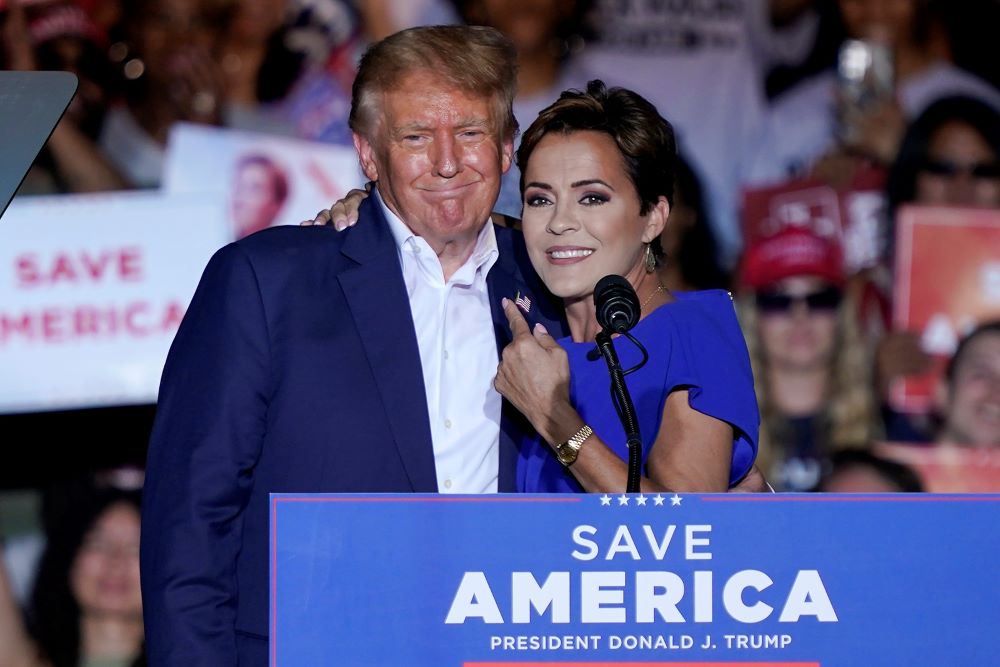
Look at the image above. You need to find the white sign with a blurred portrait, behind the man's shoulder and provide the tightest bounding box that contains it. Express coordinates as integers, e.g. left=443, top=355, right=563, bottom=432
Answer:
left=163, top=123, right=366, bottom=239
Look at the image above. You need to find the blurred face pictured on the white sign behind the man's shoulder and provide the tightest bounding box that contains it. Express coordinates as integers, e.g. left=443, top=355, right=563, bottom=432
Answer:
left=229, top=153, right=289, bottom=239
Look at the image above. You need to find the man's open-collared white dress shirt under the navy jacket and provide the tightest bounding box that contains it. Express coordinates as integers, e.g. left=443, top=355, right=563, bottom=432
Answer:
left=375, top=189, right=501, bottom=493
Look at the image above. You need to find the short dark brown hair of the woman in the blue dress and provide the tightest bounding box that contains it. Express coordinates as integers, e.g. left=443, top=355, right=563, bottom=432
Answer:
left=517, top=79, right=677, bottom=215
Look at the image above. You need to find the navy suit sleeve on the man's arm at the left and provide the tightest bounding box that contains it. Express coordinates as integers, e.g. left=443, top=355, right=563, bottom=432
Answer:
left=141, top=244, right=269, bottom=667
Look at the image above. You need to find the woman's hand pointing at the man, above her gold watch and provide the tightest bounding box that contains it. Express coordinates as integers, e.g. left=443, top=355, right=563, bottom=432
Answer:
left=493, top=299, right=583, bottom=443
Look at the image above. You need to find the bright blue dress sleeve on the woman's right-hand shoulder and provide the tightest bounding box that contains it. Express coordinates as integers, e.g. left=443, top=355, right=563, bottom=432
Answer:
left=667, top=291, right=760, bottom=486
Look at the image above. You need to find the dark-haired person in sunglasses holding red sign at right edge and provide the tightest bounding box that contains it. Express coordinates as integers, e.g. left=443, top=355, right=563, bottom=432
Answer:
left=876, top=96, right=1000, bottom=441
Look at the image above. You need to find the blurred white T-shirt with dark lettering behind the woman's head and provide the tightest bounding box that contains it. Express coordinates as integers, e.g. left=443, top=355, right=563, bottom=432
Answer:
left=578, top=0, right=817, bottom=271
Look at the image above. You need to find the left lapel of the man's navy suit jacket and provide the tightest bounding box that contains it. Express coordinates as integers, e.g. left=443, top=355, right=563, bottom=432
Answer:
left=339, top=199, right=438, bottom=492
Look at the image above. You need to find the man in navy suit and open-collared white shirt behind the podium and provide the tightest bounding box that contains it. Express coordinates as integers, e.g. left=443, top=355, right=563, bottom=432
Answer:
left=141, top=26, right=561, bottom=667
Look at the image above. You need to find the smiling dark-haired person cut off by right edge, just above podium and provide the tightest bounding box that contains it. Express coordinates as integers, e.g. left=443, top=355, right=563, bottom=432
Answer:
left=935, top=320, right=1000, bottom=447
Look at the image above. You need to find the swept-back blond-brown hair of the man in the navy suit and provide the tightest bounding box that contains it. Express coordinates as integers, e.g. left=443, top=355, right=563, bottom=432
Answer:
left=350, top=25, right=517, bottom=141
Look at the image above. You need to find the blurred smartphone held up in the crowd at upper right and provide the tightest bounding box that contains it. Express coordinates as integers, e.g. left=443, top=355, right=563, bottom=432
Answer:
left=837, top=39, right=895, bottom=144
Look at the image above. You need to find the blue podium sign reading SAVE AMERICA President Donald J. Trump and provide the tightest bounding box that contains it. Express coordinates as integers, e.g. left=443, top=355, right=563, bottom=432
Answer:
left=271, top=494, right=1000, bottom=667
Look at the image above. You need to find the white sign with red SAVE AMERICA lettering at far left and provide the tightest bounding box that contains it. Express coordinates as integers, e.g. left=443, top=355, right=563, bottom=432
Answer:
left=0, top=192, right=229, bottom=412
